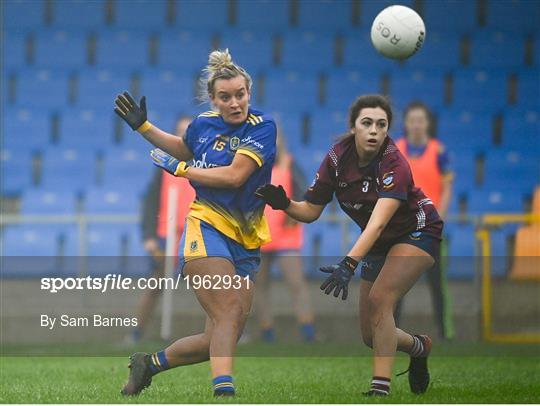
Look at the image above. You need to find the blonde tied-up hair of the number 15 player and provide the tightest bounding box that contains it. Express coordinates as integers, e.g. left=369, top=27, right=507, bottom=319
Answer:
left=200, top=49, right=252, bottom=101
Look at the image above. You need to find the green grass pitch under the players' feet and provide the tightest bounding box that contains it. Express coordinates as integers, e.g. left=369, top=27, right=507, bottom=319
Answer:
left=0, top=344, right=540, bottom=403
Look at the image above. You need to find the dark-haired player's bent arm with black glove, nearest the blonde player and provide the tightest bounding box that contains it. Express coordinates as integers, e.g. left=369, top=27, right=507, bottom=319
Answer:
left=255, top=184, right=324, bottom=223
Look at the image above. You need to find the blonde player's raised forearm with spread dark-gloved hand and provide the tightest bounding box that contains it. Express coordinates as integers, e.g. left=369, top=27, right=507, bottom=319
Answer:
left=114, top=92, right=192, bottom=161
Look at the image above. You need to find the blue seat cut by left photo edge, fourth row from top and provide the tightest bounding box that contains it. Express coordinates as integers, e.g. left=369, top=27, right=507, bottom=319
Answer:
left=3, top=108, right=51, bottom=151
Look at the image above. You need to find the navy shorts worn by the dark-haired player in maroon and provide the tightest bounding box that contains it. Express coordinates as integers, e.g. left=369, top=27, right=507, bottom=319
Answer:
left=359, top=231, right=441, bottom=282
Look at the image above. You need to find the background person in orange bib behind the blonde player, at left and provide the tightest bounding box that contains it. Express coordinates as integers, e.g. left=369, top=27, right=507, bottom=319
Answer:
left=126, top=116, right=195, bottom=344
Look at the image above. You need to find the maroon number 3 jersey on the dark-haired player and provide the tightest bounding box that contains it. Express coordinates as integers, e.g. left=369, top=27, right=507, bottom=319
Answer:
left=305, top=136, right=443, bottom=245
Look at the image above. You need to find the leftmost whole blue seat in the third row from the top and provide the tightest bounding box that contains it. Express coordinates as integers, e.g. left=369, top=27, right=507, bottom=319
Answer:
left=16, top=69, right=68, bottom=110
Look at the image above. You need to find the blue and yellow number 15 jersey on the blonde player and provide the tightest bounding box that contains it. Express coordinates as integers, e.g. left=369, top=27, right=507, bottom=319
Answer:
left=184, top=109, right=276, bottom=249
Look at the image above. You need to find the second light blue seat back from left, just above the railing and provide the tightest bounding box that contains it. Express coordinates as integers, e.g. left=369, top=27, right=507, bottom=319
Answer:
left=84, top=189, right=140, bottom=214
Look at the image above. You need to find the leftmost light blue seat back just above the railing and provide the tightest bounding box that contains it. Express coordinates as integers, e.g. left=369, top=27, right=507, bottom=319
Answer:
left=20, top=189, right=77, bottom=215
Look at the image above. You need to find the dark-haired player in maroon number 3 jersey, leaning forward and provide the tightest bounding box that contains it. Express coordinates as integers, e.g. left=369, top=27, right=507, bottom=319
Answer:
left=256, top=95, right=443, bottom=396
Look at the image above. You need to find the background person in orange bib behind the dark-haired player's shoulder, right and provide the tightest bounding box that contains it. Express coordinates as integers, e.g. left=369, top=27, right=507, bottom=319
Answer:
left=396, top=102, right=454, bottom=339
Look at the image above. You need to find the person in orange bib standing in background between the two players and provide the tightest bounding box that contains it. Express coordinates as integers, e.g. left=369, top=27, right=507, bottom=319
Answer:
left=254, top=132, right=315, bottom=342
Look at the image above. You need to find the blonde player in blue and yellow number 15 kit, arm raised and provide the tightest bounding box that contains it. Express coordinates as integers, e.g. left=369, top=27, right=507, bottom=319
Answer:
left=115, top=50, right=276, bottom=396
